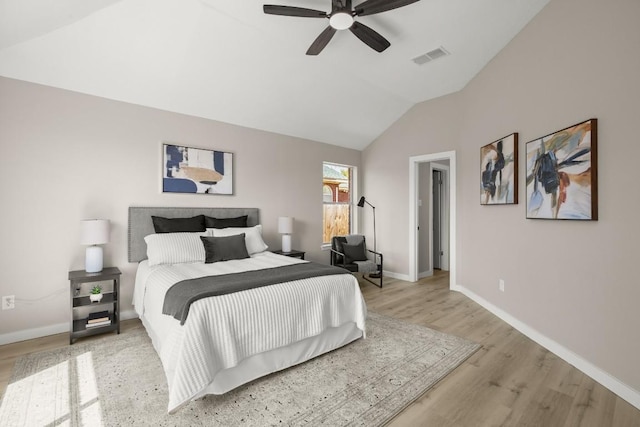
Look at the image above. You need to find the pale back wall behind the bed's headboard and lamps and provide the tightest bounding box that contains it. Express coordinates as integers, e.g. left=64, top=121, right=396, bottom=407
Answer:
left=0, top=78, right=360, bottom=343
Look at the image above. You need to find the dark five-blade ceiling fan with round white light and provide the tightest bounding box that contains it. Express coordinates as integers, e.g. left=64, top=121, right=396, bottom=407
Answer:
left=263, top=0, right=419, bottom=55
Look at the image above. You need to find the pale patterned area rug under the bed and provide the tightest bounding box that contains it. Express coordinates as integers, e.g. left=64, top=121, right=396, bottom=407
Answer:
left=0, top=313, right=479, bottom=427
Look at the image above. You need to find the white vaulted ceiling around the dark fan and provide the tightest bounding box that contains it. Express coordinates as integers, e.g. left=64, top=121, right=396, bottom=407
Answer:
left=0, top=0, right=549, bottom=149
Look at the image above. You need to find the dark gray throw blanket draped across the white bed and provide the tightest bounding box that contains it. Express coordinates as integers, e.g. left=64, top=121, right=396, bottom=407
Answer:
left=162, top=262, right=351, bottom=325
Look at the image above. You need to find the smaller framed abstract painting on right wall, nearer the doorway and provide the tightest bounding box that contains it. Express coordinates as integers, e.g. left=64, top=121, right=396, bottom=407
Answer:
left=480, top=133, right=518, bottom=205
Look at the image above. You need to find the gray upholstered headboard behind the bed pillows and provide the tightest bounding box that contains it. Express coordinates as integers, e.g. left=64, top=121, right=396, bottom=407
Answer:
left=128, top=206, right=260, bottom=262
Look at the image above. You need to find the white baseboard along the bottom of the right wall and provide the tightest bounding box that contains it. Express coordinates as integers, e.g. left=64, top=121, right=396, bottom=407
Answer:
left=451, top=285, right=640, bottom=409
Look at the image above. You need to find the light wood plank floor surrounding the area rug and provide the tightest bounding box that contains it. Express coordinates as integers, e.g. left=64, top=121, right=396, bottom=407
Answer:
left=0, top=272, right=640, bottom=427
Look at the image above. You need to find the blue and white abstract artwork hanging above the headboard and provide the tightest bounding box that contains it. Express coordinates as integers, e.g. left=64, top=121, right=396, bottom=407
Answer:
left=162, top=144, right=233, bottom=194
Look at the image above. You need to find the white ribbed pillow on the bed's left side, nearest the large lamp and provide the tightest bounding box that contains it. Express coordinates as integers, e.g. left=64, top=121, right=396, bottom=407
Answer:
left=144, top=233, right=205, bottom=265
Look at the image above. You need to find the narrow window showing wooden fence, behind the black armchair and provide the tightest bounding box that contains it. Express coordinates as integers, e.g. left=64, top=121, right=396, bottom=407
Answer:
left=322, top=162, right=354, bottom=244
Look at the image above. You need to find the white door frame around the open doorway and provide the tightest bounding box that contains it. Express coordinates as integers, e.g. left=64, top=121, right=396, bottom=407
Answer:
left=409, top=151, right=457, bottom=289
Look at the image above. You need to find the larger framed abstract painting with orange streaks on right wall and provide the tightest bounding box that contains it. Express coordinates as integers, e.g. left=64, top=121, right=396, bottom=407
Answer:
left=526, top=119, right=598, bottom=220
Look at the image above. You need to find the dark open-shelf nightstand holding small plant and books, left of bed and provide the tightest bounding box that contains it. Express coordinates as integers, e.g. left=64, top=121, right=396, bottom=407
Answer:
left=69, top=267, right=122, bottom=344
